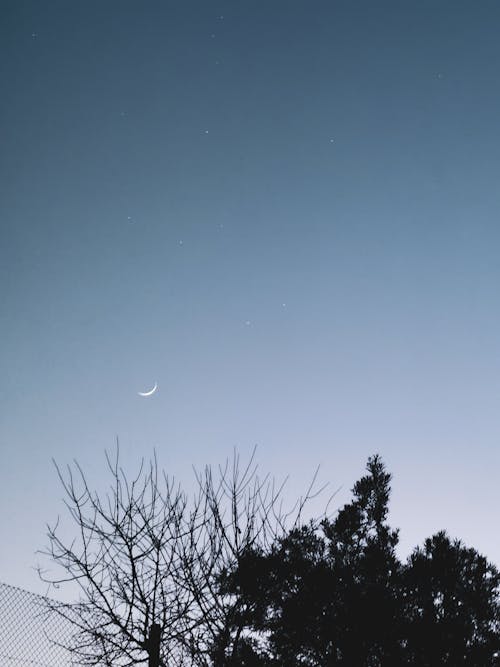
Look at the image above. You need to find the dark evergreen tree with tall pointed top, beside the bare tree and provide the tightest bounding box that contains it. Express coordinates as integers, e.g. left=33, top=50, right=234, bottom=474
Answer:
left=226, top=456, right=401, bottom=667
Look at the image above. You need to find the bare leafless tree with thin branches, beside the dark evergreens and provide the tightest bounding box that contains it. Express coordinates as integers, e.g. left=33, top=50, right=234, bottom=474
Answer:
left=39, top=445, right=328, bottom=667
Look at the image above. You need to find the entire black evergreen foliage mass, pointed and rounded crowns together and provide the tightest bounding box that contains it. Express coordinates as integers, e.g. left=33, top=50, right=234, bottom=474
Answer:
left=224, top=456, right=500, bottom=667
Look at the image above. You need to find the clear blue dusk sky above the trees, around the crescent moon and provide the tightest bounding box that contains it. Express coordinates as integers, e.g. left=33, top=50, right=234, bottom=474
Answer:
left=0, top=0, right=500, bottom=592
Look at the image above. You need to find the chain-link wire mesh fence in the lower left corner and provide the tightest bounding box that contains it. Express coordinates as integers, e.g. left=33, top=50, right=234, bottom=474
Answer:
left=0, top=583, right=76, bottom=667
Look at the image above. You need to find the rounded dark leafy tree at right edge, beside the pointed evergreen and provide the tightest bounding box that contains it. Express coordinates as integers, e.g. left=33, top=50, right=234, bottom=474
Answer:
left=404, top=531, right=500, bottom=667
